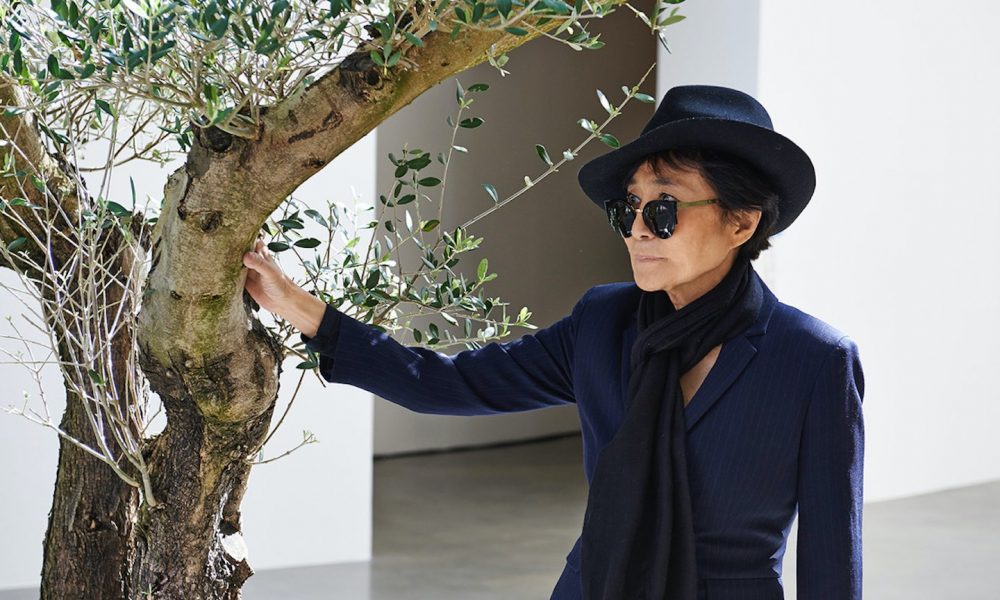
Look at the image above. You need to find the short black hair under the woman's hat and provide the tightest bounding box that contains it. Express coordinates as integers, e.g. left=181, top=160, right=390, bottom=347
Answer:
left=622, top=148, right=779, bottom=260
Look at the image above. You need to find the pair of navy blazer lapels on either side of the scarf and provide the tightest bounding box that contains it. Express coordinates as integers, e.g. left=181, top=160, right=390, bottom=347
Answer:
left=622, top=271, right=778, bottom=431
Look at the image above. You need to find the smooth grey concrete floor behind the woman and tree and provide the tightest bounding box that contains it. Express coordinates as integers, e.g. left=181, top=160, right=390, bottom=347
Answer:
left=0, top=436, right=1000, bottom=600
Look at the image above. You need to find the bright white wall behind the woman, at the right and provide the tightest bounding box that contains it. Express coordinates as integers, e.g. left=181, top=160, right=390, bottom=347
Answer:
left=758, top=0, right=1000, bottom=501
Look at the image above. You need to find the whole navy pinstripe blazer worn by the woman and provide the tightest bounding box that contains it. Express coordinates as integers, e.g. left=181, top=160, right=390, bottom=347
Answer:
left=301, top=272, right=864, bottom=600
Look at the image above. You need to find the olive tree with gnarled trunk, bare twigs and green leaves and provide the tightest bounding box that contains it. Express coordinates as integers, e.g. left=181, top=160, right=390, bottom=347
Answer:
left=0, top=0, right=683, bottom=599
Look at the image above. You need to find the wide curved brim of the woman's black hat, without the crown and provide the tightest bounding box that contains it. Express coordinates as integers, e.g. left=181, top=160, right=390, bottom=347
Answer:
left=577, top=117, right=816, bottom=235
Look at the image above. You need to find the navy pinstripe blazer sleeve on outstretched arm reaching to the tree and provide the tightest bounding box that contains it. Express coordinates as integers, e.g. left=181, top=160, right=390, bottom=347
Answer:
left=300, top=288, right=593, bottom=415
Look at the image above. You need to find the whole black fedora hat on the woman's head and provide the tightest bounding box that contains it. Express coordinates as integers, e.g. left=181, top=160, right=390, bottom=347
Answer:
left=577, top=85, right=816, bottom=235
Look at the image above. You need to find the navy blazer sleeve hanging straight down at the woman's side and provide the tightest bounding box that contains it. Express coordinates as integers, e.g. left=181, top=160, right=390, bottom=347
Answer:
left=796, top=336, right=865, bottom=600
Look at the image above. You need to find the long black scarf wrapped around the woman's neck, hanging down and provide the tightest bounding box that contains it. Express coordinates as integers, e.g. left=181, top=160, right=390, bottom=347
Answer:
left=580, top=258, right=763, bottom=600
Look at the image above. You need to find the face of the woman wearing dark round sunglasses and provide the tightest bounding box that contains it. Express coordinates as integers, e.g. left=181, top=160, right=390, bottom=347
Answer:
left=623, top=162, right=760, bottom=310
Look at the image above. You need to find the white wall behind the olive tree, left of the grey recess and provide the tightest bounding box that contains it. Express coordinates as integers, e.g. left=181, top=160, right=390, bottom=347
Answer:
left=0, top=133, right=375, bottom=589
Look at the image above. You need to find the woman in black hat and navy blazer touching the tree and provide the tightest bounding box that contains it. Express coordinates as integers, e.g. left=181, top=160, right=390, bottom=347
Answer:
left=244, top=85, right=864, bottom=600
